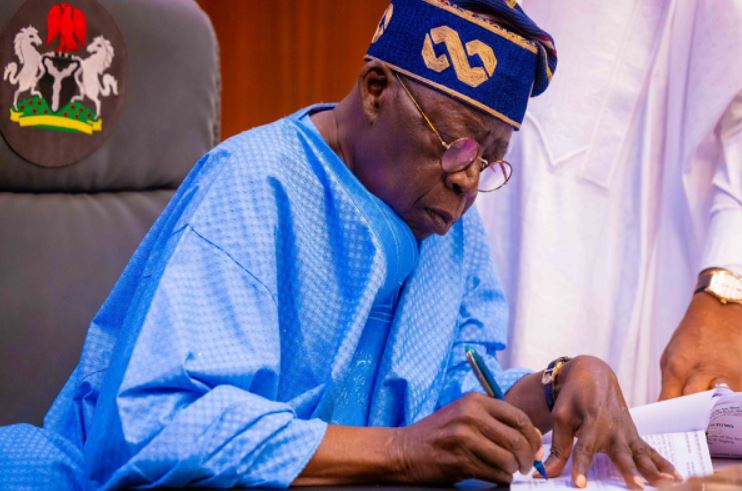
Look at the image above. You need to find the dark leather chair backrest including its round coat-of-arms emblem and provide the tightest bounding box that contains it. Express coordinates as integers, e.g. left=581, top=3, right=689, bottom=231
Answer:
left=0, top=0, right=220, bottom=425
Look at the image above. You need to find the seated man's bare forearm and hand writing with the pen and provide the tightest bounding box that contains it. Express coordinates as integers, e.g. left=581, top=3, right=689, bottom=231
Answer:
left=292, top=393, right=544, bottom=486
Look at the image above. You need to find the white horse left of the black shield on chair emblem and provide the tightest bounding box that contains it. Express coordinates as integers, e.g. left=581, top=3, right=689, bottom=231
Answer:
left=3, top=26, right=44, bottom=108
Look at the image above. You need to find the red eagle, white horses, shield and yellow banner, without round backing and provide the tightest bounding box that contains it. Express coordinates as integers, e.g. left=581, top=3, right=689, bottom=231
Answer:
left=3, top=2, right=118, bottom=135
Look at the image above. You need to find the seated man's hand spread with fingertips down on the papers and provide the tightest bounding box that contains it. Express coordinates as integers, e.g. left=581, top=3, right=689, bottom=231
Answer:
left=545, top=356, right=682, bottom=489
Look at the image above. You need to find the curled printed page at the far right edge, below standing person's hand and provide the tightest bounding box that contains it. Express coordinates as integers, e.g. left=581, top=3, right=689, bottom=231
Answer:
left=706, top=392, right=742, bottom=458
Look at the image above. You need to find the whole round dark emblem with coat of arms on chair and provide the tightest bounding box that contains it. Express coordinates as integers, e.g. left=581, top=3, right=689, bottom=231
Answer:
left=0, top=0, right=126, bottom=167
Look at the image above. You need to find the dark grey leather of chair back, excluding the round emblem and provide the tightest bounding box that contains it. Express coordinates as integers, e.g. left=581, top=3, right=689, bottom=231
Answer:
left=0, top=0, right=220, bottom=425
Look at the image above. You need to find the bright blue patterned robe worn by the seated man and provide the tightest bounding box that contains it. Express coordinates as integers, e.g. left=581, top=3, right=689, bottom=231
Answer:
left=0, top=106, right=526, bottom=488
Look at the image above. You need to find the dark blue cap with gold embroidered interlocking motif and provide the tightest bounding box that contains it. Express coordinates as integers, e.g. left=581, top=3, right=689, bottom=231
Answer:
left=366, top=0, right=557, bottom=129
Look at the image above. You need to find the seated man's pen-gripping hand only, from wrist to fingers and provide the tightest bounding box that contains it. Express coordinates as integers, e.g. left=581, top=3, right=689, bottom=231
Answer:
left=394, top=393, right=543, bottom=484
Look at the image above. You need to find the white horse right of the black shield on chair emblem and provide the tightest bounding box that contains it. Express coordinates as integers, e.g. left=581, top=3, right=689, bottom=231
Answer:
left=72, top=36, right=118, bottom=118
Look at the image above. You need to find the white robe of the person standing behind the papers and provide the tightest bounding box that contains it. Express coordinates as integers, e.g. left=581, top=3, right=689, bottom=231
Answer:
left=478, top=0, right=742, bottom=404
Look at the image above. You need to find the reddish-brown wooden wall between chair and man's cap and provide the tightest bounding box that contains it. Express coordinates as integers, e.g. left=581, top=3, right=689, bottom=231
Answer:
left=198, top=0, right=388, bottom=138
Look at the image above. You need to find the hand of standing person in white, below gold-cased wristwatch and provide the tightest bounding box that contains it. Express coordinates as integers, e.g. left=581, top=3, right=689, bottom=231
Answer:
left=660, top=292, right=742, bottom=400
